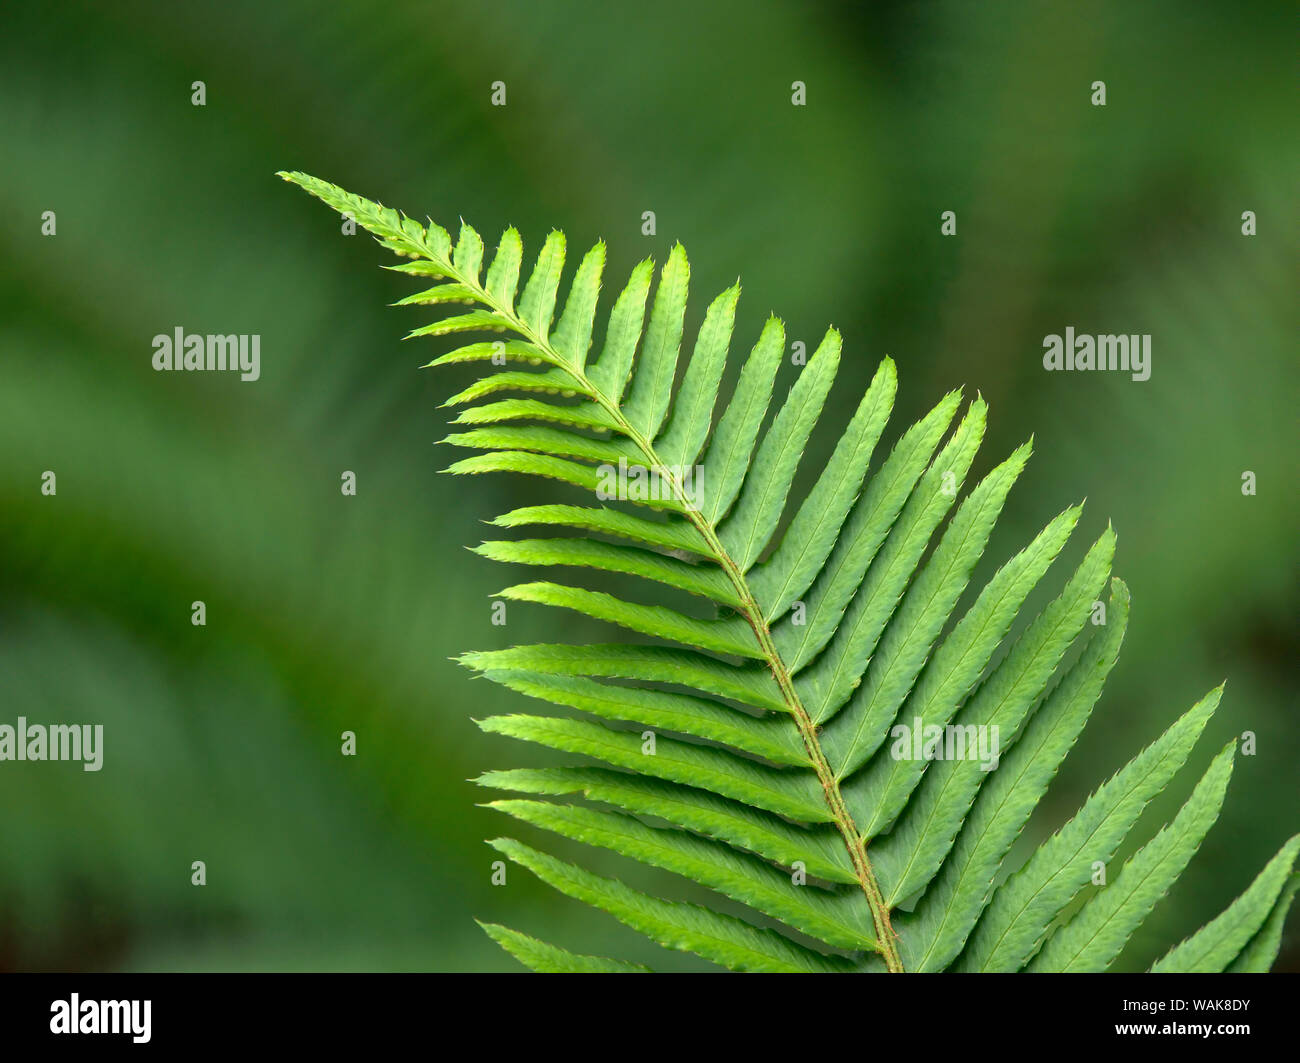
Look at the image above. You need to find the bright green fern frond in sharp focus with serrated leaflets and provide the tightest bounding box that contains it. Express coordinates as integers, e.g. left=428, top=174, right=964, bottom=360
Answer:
left=281, top=173, right=1300, bottom=971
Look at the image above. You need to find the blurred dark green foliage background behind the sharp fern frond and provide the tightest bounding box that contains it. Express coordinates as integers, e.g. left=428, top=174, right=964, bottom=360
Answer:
left=0, top=0, right=1300, bottom=969
